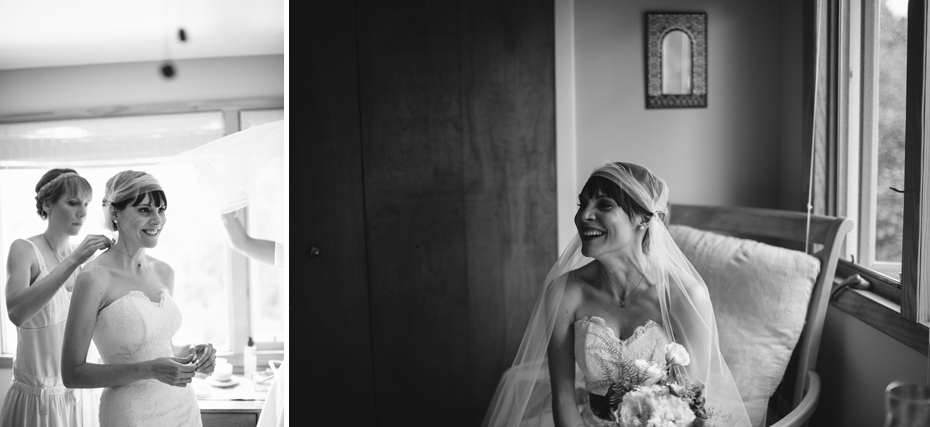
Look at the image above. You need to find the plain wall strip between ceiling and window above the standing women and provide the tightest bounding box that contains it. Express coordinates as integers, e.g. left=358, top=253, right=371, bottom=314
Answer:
left=0, top=55, right=284, bottom=399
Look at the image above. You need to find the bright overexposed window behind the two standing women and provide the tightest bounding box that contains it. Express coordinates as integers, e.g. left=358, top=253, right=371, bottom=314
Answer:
left=0, top=104, right=287, bottom=354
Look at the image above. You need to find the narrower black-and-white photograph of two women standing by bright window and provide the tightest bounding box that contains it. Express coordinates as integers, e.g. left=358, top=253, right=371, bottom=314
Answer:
left=0, top=0, right=286, bottom=427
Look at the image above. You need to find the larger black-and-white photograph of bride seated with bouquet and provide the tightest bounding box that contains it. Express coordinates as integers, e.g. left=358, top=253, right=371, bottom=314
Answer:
left=314, top=0, right=930, bottom=427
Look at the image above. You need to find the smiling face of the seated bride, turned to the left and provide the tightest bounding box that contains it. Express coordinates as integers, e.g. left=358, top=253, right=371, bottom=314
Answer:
left=575, top=192, right=638, bottom=258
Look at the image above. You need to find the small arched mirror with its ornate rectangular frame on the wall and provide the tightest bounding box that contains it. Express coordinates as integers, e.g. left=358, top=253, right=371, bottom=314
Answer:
left=646, top=12, right=707, bottom=108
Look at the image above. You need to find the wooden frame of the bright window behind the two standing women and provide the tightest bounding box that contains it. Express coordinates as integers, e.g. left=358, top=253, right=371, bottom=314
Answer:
left=0, top=97, right=284, bottom=374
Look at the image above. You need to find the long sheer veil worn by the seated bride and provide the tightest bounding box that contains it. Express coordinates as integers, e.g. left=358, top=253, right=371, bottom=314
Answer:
left=482, top=162, right=750, bottom=427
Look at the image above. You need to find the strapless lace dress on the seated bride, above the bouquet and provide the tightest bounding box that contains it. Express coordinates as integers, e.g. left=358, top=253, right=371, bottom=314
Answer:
left=575, top=316, right=669, bottom=427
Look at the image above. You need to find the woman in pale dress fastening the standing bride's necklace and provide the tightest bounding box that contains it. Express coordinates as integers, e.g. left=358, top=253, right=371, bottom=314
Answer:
left=0, top=169, right=113, bottom=427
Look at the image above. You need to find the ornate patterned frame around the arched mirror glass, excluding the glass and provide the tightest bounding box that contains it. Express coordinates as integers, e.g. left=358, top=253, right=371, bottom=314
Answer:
left=646, top=12, right=707, bottom=108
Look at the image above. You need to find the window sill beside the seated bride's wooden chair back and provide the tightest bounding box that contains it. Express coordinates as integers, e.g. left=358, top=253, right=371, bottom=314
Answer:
left=830, top=269, right=928, bottom=354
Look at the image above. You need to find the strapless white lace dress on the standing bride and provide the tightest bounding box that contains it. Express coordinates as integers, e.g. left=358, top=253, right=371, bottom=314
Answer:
left=94, top=291, right=202, bottom=427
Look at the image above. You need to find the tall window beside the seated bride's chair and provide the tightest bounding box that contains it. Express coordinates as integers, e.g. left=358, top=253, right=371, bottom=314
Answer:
left=839, top=0, right=930, bottom=320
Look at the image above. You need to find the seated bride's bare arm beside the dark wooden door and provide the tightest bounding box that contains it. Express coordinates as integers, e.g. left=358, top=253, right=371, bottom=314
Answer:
left=547, top=281, right=584, bottom=427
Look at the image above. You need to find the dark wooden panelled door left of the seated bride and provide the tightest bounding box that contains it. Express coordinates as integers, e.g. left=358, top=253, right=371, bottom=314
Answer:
left=308, top=0, right=557, bottom=426
